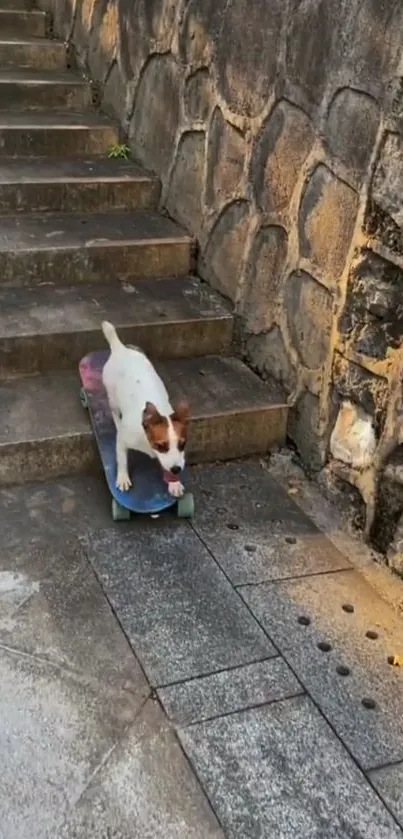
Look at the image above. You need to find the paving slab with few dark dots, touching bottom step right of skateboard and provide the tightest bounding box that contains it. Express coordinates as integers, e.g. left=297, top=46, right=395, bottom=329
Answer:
left=193, top=463, right=350, bottom=585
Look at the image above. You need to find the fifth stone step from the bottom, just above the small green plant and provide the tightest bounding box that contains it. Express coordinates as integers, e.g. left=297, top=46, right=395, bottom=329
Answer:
left=0, top=111, right=119, bottom=156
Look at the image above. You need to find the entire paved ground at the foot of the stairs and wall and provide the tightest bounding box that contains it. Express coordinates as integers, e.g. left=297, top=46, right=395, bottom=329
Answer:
left=0, top=460, right=403, bottom=839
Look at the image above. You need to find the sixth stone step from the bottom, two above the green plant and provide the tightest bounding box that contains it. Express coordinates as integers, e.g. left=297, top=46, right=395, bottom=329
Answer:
left=0, top=68, right=92, bottom=111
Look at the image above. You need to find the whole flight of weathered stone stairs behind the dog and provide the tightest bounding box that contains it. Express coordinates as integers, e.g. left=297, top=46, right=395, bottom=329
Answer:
left=0, top=0, right=287, bottom=485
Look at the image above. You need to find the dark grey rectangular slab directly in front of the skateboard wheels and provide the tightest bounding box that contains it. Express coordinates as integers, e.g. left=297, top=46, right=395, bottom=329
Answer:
left=84, top=519, right=275, bottom=686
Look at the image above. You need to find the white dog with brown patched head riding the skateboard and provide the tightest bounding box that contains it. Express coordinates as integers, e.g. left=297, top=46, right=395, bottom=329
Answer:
left=102, top=321, right=190, bottom=498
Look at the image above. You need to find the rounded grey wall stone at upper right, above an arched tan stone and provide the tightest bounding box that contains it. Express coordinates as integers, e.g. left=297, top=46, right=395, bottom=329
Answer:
left=326, top=88, right=380, bottom=186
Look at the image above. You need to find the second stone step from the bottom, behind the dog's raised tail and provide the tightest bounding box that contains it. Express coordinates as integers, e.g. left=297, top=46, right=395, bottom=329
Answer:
left=0, top=277, right=233, bottom=379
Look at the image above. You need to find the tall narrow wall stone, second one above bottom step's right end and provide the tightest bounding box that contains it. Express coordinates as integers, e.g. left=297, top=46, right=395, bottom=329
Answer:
left=239, top=226, right=288, bottom=334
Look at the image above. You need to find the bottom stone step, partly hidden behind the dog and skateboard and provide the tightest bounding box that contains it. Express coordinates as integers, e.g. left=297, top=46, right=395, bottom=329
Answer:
left=0, top=356, right=287, bottom=486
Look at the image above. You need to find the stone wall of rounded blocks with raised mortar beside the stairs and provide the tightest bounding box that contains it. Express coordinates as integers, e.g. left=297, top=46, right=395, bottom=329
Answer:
left=41, top=0, right=403, bottom=556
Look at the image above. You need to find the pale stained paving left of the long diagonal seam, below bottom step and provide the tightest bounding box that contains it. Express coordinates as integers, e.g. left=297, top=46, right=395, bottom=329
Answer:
left=0, top=477, right=224, bottom=839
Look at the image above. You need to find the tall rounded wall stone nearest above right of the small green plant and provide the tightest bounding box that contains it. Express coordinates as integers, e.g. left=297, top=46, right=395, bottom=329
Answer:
left=129, top=55, right=180, bottom=182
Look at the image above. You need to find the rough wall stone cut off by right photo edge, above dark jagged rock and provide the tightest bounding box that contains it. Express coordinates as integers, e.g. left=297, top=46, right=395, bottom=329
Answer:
left=372, top=134, right=403, bottom=227
